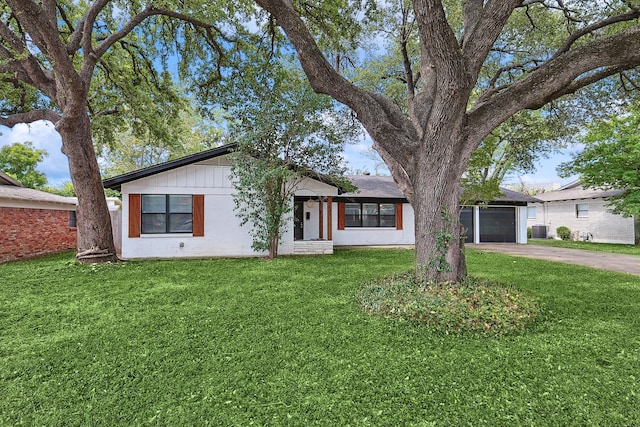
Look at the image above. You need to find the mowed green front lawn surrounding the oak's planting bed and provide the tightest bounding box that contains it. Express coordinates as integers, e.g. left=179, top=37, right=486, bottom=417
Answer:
left=0, top=249, right=640, bottom=426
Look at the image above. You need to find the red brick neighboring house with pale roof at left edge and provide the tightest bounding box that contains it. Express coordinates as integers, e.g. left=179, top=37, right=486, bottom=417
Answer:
left=0, top=172, right=77, bottom=263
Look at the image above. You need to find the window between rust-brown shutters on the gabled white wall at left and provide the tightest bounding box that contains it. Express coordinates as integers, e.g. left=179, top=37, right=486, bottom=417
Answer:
left=141, top=194, right=193, bottom=234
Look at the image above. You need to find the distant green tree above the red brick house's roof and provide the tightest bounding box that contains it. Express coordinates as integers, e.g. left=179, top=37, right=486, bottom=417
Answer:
left=0, top=142, right=48, bottom=189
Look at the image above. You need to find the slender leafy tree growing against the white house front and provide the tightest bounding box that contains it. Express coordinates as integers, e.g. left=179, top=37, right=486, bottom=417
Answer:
left=225, top=64, right=359, bottom=258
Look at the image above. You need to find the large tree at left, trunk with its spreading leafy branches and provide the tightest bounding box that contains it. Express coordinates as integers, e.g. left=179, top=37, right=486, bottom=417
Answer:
left=0, top=0, right=235, bottom=262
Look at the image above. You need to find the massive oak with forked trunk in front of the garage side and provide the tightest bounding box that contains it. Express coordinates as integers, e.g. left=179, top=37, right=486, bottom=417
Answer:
left=256, top=0, right=640, bottom=280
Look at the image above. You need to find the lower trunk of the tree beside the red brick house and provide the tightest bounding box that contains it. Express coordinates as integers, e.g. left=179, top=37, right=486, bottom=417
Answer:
left=56, top=112, right=118, bottom=263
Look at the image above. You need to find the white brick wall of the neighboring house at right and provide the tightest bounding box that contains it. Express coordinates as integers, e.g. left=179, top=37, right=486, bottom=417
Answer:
left=527, top=199, right=634, bottom=244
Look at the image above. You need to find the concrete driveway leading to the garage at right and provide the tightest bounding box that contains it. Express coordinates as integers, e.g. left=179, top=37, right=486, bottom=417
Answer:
left=466, top=243, right=640, bottom=275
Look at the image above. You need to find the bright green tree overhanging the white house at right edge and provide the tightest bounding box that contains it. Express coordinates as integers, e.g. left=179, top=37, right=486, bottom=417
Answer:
left=558, top=103, right=640, bottom=216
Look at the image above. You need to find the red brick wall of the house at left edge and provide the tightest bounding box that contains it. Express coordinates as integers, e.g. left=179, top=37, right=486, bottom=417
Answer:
left=0, top=207, right=76, bottom=263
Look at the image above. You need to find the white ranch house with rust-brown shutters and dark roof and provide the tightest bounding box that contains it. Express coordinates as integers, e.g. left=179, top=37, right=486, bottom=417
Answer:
left=104, top=145, right=535, bottom=259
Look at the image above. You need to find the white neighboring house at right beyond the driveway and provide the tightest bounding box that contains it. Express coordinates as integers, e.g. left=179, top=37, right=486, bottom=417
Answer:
left=527, top=181, right=640, bottom=245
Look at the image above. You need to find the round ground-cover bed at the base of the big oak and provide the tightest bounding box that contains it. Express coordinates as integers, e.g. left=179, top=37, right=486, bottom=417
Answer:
left=357, top=272, right=538, bottom=336
